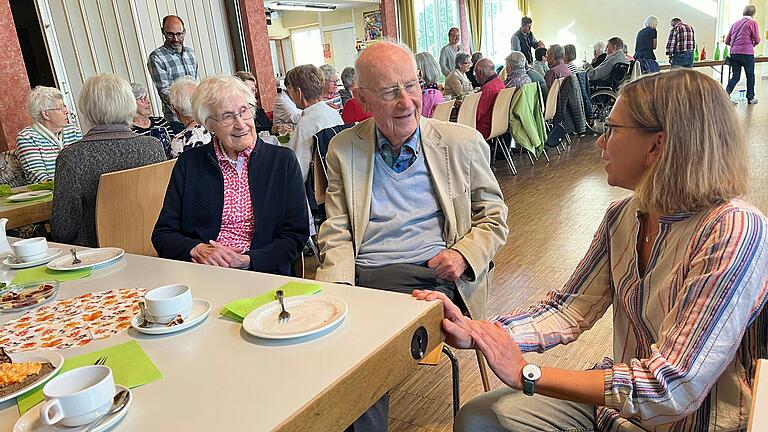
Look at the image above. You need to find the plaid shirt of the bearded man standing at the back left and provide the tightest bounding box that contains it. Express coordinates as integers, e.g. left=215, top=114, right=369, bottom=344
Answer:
left=147, top=45, right=200, bottom=121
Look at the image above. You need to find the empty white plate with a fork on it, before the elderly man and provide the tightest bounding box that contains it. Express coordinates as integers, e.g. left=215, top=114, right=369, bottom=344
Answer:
left=243, top=294, right=347, bottom=339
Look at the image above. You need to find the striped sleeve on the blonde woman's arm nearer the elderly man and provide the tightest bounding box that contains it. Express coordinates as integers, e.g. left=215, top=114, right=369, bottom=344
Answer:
left=491, top=198, right=629, bottom=352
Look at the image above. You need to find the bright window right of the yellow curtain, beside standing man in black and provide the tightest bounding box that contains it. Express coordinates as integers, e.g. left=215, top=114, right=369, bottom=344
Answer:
left=480, top=0, right=520, bottom=65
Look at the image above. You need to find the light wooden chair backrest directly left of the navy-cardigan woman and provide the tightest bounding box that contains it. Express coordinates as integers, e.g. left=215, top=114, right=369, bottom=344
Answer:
left=96, top=159, right=176, bottom=256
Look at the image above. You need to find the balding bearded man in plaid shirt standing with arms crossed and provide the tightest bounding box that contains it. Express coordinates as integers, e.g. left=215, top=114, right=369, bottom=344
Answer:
left=147, top=15, right=200, bottom=134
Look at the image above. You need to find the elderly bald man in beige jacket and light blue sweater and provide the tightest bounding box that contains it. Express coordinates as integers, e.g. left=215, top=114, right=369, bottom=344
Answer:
left=317, top=38, right=508, bottom=431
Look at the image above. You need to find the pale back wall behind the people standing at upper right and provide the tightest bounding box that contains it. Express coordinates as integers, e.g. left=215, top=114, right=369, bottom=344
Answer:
left=528, top=0, right=719, bottom=60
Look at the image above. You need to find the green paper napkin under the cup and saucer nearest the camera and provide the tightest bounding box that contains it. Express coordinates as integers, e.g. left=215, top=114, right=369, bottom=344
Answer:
left=16, top=340, right=163, bottom=415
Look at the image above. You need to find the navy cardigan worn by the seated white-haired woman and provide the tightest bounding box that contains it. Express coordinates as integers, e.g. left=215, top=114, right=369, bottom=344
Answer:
left=152, top=139, right=309, bottom=275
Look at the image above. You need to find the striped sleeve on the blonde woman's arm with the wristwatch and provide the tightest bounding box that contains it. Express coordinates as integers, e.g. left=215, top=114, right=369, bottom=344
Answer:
left=605, top=207, right=768, bottom=425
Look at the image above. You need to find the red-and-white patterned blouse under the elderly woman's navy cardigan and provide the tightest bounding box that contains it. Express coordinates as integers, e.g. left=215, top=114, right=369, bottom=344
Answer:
left=213, top=138, right=256, bottom=252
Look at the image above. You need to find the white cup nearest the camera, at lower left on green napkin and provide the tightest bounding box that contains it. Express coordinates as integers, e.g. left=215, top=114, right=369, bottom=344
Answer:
left=40, top=366, right=115, bottom=427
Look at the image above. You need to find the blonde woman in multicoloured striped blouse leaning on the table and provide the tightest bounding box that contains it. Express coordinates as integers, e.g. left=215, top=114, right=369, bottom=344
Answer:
left=414, top=69, right=768, bottom=431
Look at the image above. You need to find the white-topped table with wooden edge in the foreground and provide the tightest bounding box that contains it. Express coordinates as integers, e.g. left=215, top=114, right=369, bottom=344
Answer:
left=0, top=248, right=442, bottom=431
